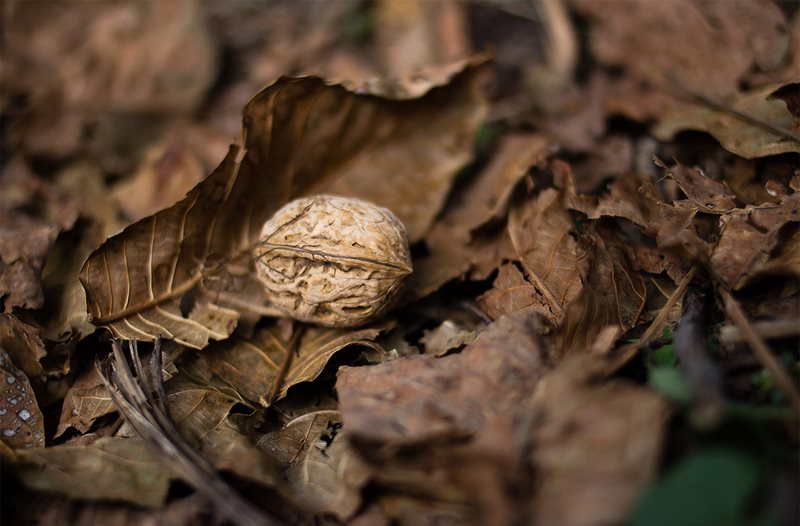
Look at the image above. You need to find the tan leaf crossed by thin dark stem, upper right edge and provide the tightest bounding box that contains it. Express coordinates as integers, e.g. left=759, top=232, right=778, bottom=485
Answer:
left=653, top=84, right=800, bottom=159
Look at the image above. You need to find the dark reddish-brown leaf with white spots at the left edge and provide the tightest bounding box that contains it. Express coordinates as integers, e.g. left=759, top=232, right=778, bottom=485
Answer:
left=0, top=349, right=44, bottom=449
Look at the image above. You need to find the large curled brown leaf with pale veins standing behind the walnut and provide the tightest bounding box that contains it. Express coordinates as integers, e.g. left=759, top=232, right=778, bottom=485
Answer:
left=81, top=59, right=484, bottom=348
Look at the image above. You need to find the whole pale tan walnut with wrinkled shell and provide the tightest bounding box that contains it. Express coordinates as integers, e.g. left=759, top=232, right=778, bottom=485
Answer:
left=255, top=195, right=411, bottom=327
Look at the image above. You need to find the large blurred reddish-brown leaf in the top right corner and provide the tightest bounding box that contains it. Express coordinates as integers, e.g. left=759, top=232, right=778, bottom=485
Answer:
left=571, top=0, right=791, bottom=96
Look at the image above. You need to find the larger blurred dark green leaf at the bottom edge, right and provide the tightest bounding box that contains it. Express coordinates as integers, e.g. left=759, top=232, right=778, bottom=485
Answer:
left=630, top=448, right=760, bottom=526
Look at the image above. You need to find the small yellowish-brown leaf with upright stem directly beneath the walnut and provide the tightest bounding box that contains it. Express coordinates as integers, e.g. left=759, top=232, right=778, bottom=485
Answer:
left=176, top=324, right=386, bottom=407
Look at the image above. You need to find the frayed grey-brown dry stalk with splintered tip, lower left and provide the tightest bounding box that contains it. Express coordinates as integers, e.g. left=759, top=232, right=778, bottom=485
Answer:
left=95, top=341, right=281, bottom=526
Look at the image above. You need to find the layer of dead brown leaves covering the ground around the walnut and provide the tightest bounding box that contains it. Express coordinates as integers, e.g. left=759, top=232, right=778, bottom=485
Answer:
left=0, top=0, right=800, bottom=526
